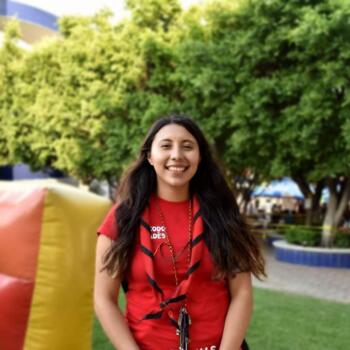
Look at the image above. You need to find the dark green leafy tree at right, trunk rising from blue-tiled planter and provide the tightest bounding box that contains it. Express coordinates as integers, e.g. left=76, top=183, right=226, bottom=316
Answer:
left=208, top=0, right=350, bottom=245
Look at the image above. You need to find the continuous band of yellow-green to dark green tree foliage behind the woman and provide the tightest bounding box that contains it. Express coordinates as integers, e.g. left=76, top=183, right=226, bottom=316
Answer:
left=0, top=0, right=350, bottom=202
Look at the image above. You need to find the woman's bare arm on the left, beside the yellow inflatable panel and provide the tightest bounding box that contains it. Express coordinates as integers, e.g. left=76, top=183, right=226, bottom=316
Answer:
left=94, top=235, right=139, bottom=350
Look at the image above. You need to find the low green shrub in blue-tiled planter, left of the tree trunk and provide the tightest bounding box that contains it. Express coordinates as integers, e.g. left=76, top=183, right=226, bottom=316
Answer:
left=284, top=226, right=321, bottom=247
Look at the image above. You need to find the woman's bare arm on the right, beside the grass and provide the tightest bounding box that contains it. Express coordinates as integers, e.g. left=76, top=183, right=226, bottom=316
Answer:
left=220, top=272, right=253, bottom=350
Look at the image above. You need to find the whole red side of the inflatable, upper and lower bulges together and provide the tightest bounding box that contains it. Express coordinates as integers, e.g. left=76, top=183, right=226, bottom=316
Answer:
left=0, top=188, right=46, bottom=350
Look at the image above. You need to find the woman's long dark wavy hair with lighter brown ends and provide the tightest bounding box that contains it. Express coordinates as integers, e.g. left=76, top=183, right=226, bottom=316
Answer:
left=103, top=115, right=266, bottom=279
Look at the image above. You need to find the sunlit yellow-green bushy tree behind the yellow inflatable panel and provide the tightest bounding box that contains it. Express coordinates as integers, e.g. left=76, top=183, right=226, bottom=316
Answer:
left=16, top=13, right=143, bottom=183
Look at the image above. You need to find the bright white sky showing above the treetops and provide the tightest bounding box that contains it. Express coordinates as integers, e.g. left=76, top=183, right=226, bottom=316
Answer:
left=16, top=0, right=203, bottom=19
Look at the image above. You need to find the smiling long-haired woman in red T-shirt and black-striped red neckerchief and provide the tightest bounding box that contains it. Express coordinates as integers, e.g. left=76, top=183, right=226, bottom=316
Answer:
left=94, top=116, right=265, bottom=350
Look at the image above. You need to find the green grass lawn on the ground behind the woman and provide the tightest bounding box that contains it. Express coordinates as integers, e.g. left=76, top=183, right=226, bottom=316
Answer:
left=93, top=288, right=350, bottom=350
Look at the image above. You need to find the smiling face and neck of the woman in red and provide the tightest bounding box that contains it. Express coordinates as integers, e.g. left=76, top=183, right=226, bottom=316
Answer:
left=148, top=124, right=200, bottom=195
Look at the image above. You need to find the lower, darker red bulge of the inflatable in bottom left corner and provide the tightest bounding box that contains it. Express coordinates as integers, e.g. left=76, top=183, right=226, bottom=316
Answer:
left=0, top=273, right=34, bottom=350
